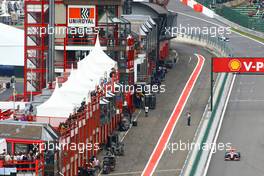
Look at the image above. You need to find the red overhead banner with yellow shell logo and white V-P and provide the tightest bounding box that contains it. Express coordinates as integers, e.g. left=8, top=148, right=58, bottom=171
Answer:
left=212, top=58, right=264, bottom=73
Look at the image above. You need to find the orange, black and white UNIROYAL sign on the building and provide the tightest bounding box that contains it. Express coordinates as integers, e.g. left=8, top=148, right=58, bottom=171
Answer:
left=68, top=5, right=96, bottom=27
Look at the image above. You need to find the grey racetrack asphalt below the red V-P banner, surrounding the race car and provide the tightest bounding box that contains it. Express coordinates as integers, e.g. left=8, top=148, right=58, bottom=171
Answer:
left=207, top=75, right=264, bottom=176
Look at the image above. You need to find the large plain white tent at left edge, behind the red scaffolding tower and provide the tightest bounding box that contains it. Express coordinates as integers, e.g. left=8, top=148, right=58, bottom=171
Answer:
left=0, top=23, right=24, bottom=66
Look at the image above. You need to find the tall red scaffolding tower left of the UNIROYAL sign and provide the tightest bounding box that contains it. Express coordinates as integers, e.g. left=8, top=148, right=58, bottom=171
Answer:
left=24, top=0, right=55, bottom=98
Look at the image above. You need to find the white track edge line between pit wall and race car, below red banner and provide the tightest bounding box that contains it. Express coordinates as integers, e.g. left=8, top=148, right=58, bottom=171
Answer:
left=203, top=75, right=236, bottom=176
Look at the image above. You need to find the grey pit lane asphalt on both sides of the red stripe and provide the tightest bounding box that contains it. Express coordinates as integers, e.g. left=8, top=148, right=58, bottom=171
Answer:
left=105, top=42, right=212, bottom=176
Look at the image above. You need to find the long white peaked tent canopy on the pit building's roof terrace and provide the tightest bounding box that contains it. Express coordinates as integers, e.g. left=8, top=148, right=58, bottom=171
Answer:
left=37, top=36, right=117, bottom=126
